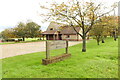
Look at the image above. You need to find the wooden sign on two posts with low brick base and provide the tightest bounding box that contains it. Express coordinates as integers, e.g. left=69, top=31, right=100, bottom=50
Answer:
left=42, top=41, right=71, bottom=65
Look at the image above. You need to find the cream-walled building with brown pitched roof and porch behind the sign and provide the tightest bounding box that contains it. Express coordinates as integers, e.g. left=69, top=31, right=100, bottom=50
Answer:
left=42, top=22, right=82, bottom=41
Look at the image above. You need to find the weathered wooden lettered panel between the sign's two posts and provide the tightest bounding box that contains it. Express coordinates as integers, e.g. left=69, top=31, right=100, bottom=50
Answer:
left=47, top=41, right=66, bottom=50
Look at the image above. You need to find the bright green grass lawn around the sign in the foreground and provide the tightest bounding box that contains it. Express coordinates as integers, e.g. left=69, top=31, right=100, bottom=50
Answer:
left=2, top=38, right=118, bottom=78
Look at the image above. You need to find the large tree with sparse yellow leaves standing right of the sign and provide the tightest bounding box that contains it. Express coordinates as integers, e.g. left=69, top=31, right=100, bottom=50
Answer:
left=41, top=0, right=115, bottom=52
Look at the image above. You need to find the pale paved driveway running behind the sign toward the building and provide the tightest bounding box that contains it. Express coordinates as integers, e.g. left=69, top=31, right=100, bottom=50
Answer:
left=0, top=41, right=81, bottom=58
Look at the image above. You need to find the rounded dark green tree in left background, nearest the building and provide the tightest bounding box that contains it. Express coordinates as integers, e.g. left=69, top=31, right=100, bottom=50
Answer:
left=26, top=22, right=40, bottom=38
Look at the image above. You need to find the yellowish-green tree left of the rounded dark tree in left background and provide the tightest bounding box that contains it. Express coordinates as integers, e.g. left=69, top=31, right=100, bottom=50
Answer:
left=14, top=22, right=27, bottom=41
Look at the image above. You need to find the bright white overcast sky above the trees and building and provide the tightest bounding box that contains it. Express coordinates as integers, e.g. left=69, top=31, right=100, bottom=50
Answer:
left=0, top=0, right=119, bottom=31
